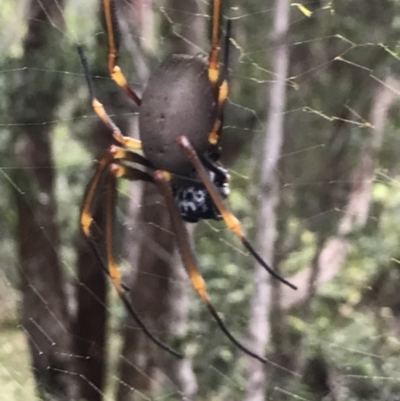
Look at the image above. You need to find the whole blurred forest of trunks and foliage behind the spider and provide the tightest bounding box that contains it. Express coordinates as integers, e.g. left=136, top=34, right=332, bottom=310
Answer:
left=0, top=0, right=400, bottom=401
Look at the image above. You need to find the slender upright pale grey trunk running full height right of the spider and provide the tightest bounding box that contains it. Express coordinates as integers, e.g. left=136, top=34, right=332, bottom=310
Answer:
left=246, top=0, right=290, bottom=401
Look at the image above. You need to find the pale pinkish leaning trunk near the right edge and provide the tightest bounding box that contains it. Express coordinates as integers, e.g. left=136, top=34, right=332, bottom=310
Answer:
left=281, top=77, right=400, bottom=309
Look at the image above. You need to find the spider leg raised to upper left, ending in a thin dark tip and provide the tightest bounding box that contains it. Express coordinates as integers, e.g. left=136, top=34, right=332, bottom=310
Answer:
left=78, top=46, right=142, bottom=149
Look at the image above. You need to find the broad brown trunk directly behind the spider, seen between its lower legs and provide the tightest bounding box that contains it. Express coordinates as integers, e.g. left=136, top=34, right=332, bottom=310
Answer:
left=117, top=1, right=204, bottom=401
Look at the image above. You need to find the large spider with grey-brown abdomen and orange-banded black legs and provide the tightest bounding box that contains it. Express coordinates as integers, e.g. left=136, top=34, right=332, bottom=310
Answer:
left=78, top=0, right=296, bottom=363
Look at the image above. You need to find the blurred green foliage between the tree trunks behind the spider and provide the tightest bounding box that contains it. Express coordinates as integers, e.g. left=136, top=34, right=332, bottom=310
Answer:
left=0, top=0, right=400, bottom=401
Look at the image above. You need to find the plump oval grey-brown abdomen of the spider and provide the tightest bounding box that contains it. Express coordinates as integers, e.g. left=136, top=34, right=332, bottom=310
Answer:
left=139, top=55, right=216, bottom=175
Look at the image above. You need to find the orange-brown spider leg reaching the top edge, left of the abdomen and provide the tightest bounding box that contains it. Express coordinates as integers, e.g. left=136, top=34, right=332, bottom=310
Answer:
left=103, top=0, right=141, bottom=106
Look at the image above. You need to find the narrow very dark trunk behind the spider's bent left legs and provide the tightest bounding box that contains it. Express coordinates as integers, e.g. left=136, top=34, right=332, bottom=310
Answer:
left=74, top=3, right=135, bottom=401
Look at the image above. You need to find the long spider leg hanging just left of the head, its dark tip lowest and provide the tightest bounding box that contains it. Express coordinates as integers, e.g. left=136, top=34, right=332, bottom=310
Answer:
left=154, top=170, right=266, bottom=363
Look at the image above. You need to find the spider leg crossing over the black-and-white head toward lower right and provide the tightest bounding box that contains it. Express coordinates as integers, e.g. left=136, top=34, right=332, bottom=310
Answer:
left=177, top=136, right=297, bottom=290
